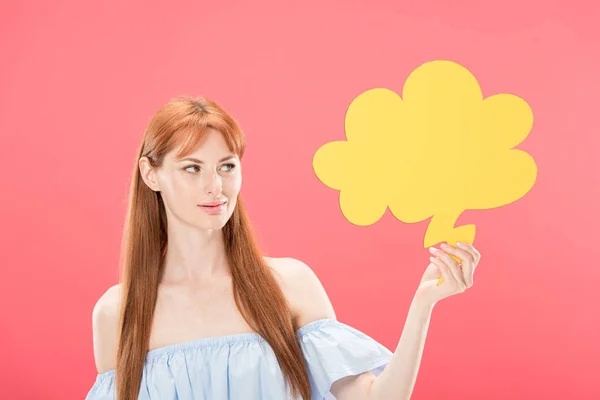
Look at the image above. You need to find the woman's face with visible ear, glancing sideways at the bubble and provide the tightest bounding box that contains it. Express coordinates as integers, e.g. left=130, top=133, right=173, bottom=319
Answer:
left=140, top=129, right=242, bottom=229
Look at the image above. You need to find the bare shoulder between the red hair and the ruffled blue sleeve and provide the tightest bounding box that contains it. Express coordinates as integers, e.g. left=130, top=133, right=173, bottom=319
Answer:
left=265, top=257, right=336, bottom=327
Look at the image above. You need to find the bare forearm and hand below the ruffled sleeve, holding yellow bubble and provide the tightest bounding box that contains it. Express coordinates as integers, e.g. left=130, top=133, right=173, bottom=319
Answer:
left=331, top=244, right=481, bottom=400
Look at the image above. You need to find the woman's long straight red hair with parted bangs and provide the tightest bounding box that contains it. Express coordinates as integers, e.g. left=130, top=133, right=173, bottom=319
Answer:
left=116, top=98, right=311, bottom=400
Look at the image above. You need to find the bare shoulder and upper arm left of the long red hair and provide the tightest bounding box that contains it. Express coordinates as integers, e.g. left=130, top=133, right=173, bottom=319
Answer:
left=92, top=285, right=121, bottom=373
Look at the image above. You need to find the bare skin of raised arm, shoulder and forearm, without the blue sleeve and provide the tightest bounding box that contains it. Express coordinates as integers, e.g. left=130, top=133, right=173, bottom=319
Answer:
left=276, top=241, right=481, bottom=400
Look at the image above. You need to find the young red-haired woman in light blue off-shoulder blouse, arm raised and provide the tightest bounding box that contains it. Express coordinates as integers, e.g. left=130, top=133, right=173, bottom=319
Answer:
left=87, top=98, right=480, bottom=400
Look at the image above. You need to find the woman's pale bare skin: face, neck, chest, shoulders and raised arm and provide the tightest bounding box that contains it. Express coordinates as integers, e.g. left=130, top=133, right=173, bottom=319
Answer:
left=93, top=131, right=481, bottom=400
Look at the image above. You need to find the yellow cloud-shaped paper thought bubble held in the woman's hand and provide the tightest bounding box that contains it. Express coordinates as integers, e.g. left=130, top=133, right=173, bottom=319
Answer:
left=313, top=60, right=537, bottom=260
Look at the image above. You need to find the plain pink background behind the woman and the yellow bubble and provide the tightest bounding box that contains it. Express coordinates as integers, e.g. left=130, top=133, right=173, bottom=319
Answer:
left=0, top=0, right=600, bottom=400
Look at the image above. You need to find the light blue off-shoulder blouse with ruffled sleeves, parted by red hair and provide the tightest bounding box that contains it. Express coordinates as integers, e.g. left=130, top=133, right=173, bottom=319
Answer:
left=86, top=319, right=392, bottom=400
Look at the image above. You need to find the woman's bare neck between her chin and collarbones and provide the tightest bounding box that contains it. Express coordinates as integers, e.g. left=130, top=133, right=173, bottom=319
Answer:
left=162, top=221, right=230, bottom=283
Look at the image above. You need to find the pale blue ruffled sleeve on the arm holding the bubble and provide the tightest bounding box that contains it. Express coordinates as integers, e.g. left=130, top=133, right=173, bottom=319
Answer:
left=297, top=319, right=393, bottom=400
